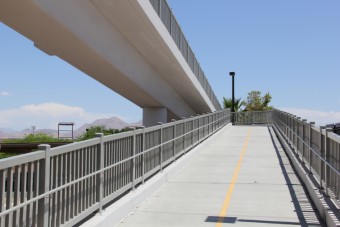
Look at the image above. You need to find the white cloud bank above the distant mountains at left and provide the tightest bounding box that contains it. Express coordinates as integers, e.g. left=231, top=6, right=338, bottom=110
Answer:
left=0, top=103, right=112, bottom=130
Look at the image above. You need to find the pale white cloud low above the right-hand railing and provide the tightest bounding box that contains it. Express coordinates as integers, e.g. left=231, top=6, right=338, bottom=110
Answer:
left=280, top=108, right=340, bottom=126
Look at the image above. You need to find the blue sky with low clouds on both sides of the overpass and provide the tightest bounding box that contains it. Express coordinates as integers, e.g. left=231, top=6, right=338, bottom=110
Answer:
left=0, top=0, right=340, bottom=129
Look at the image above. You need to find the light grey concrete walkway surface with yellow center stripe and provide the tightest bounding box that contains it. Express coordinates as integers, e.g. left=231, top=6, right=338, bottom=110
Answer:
left=115, top=126, right=323, bottom=227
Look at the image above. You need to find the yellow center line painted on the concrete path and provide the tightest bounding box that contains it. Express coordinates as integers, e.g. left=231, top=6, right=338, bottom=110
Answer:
left=216, top=129, right=251, bottom=227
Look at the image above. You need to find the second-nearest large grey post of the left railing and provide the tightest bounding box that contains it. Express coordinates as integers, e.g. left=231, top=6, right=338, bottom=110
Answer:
left=96, top=133, right=104, bottom=214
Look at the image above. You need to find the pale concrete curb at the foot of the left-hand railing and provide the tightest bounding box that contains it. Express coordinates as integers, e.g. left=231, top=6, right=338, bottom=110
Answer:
left=80, top=123, right=231, bottom=227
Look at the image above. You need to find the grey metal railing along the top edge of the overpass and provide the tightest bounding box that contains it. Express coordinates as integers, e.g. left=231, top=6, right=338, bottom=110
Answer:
left=150, top=0, right=222, bottom=110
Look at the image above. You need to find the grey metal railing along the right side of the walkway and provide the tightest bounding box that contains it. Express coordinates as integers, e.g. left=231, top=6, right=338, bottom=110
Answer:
left=273, top=110, right=340, bottom=200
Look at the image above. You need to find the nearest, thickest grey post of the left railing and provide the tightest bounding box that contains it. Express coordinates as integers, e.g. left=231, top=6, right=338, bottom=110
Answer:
left=38, top=144, right=51, bottom=227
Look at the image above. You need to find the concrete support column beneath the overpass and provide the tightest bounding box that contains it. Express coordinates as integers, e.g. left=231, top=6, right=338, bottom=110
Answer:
left=143, top=107, right=168, bottom=127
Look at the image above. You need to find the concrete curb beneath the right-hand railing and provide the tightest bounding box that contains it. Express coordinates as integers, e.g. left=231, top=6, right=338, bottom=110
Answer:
left=273, top=125, right=340, bottom=227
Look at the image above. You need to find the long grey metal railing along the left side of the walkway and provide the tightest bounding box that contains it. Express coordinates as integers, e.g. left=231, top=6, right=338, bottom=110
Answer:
left=0, top=110, right=230, bottom=227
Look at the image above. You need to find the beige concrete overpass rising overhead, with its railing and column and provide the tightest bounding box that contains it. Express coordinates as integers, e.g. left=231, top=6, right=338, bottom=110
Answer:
left=0, top=0, right=220, bottom=126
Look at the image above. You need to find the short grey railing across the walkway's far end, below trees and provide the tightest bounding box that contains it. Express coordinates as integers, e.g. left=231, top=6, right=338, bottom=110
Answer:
left=231, top=111, right=272, bottom=125
